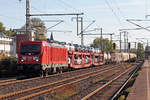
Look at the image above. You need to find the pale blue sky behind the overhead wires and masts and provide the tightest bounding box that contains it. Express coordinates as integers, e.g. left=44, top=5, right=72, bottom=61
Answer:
left=0, top=0, right=150, bottom=47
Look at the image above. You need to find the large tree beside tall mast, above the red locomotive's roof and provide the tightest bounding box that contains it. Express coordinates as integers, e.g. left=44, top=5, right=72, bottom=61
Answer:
left=21, top=18, right=46, bottom=40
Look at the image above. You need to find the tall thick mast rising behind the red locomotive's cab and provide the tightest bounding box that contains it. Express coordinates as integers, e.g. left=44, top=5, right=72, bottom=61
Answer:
left=26, top=0, right=31, bottom=41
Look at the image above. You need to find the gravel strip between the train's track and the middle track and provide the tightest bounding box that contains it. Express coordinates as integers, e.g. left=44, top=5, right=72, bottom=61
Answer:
left=0, top=65, right=117, bottom=95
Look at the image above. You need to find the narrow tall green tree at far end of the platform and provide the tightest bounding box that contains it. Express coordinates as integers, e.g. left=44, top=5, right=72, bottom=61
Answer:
left=137, top=43, right=145, bottom=60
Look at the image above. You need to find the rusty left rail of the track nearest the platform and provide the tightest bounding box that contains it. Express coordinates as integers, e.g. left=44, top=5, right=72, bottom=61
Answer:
left=81, top=67, right=135, bottom=100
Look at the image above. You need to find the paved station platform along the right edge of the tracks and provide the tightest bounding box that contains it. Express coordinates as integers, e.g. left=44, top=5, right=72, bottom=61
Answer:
left=127, top=60, right=150, bottom=100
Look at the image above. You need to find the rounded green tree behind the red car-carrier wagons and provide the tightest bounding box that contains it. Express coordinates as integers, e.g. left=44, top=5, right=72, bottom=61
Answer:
left=91, top=38, right=115, bottom=52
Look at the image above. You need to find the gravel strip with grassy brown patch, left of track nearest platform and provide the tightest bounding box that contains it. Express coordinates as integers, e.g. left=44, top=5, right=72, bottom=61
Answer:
left=27, top=63, right=135, bottom=100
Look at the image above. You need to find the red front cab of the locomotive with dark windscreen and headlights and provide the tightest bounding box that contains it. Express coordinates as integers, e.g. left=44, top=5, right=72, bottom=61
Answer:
left=17, top=41, right=42, bottom=74
